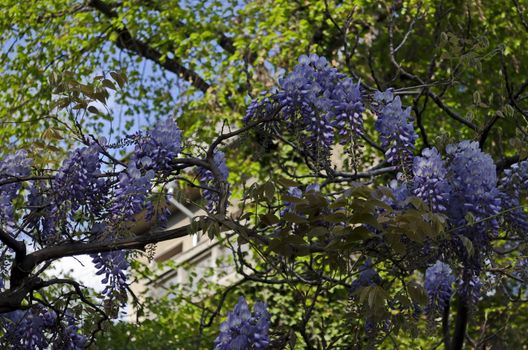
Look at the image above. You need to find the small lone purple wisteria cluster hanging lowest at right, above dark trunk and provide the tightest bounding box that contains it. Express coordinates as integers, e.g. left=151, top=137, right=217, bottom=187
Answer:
left=424, top=260, right=455, bottom=313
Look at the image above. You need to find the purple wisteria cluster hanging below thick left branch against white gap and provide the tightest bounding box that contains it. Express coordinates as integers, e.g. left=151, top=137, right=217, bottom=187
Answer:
left=91, top=250, right=130, bottom=297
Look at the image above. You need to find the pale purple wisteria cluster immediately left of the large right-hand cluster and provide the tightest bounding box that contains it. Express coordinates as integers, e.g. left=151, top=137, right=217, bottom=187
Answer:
left=413, top=148, right=451, bottom=212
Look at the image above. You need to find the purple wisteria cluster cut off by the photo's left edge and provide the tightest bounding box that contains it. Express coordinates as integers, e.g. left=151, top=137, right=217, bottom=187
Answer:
left=0, top=151, right=32, bottom=223
